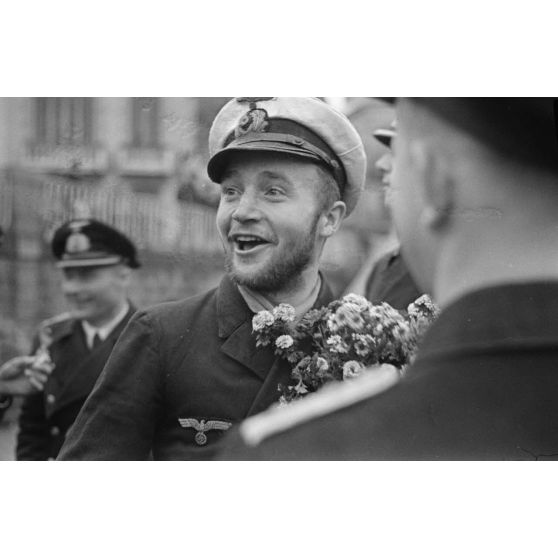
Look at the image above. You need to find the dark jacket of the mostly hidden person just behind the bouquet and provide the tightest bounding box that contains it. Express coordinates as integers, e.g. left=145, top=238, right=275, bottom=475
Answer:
left=365, top=249, right=423, bottom=310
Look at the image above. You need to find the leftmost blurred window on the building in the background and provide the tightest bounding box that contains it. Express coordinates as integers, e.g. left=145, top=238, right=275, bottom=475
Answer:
left=36, top=97, right=93, bottom=145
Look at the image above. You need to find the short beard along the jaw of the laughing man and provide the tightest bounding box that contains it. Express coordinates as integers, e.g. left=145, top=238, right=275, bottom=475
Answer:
left=225, top=216, right=319, bottom=293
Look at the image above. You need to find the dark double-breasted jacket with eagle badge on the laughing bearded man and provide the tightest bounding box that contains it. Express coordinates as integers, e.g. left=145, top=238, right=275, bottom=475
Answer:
left=60, top=277, right=331, bottom=460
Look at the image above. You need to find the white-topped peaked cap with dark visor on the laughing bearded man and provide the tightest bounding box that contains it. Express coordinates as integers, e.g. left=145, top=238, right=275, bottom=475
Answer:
left=207, top=97, right=366, bottom=214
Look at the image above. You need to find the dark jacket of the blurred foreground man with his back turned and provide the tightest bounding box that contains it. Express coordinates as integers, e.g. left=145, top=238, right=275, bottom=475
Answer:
left=223, top=282, right=558, bottom=460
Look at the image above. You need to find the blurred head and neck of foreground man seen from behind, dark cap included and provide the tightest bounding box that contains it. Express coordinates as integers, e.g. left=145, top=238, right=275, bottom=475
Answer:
left=394, top=98, right=558, bottom=303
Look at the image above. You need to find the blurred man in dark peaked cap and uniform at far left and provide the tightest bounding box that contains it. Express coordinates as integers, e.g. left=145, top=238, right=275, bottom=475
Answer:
left=10, top=219, right=140, bottom=460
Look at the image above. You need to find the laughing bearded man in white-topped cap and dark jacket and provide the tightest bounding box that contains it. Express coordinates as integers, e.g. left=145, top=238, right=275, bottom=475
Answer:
left=61, top=97, right=366, bottom=460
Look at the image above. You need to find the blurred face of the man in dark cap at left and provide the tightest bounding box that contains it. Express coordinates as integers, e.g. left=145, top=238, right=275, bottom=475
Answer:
left=62, top=265, right=128, bottom=326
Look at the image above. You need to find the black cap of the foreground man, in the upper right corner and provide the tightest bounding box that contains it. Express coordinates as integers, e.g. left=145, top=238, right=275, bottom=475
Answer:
left=411, top=97, right=558, bottom=173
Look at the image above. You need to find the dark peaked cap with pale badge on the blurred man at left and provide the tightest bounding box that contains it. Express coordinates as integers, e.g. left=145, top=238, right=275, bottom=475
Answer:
left=52, top=219, right=140, bottom=269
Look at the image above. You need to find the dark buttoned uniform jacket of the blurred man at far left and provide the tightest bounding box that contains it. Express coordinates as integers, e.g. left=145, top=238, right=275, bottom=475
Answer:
left=16, top=308, right=135, bottom=460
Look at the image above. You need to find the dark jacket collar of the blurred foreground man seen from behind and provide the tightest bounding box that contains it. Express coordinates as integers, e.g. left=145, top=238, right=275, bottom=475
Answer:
left=417, top=281, right=558, bottom=361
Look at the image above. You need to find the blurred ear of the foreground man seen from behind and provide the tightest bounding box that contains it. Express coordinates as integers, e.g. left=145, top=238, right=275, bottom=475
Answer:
left=410, top=142, right=456, bottom=231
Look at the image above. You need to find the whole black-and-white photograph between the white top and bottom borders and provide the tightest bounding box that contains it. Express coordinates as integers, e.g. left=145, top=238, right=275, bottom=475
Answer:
left=0, top=97, right=558, bottom=461
